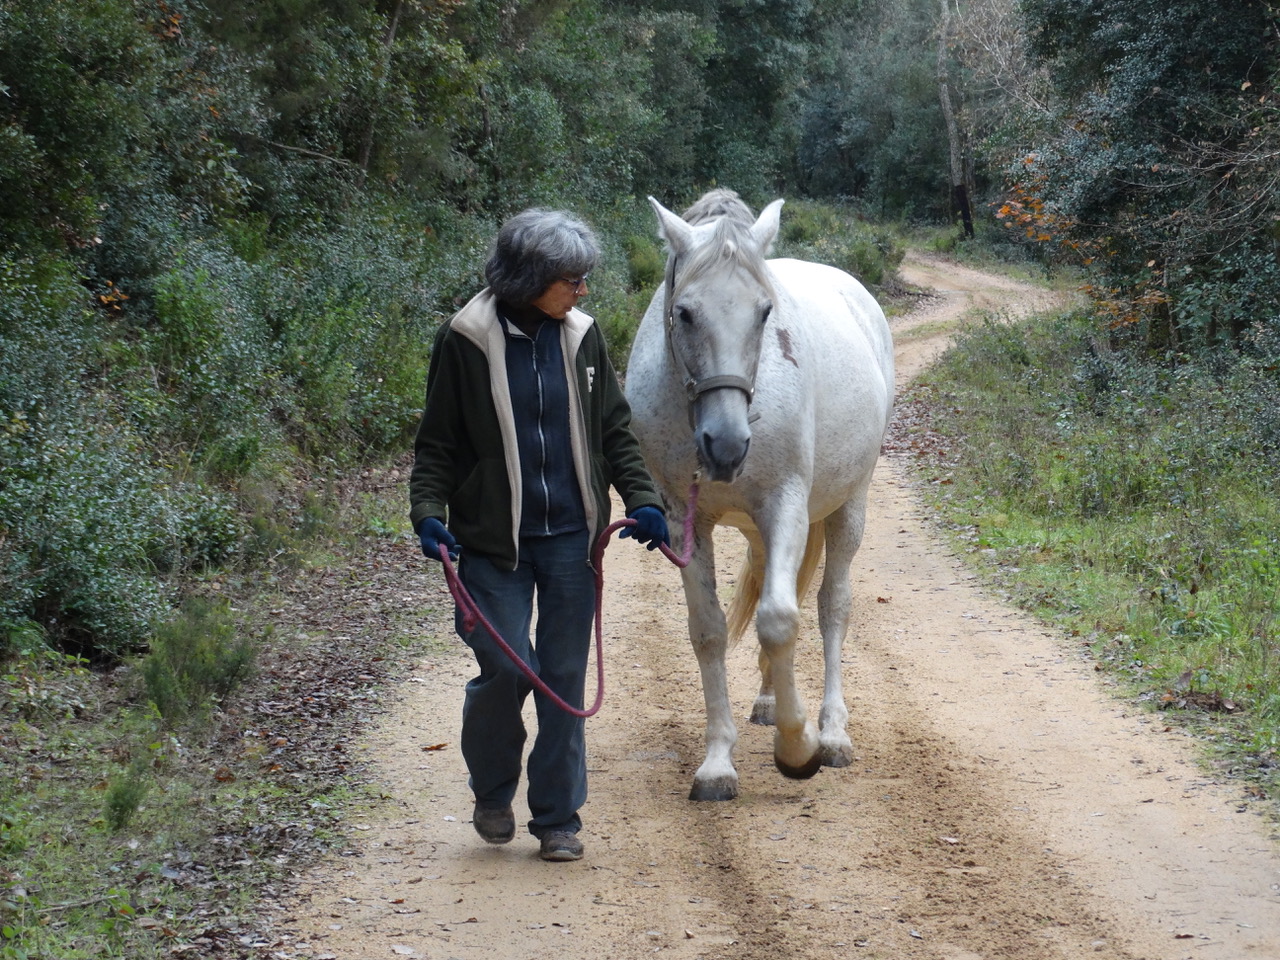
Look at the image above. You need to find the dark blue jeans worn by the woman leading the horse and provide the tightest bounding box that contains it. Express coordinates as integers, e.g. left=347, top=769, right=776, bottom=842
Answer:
left=454, top=530, right=595, bottom=837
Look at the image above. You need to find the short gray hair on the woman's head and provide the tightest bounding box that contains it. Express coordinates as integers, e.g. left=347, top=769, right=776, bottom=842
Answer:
left=484, top=207, right=600, bottom=306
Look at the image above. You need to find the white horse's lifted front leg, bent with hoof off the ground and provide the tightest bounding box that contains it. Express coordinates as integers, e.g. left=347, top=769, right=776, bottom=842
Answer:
left=755, top=504, right=822, bottom=780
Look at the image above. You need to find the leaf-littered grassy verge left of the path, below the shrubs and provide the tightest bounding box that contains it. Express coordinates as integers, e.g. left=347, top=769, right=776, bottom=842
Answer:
left=0, top=468, right=451, bottom=960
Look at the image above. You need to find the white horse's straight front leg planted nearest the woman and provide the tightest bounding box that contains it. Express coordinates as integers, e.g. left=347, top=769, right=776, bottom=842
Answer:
left=681, top=524, right=737, bottom=800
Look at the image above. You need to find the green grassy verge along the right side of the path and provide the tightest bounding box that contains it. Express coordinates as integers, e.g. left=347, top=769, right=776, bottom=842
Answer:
left=901, top=315, right=1280, bottom=795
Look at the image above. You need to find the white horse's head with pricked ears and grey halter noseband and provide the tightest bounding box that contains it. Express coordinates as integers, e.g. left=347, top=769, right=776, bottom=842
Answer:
left=649, top=191, right=782, bottom=483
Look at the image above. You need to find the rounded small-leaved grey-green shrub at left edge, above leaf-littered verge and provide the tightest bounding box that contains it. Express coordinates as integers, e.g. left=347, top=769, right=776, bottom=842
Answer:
left=0, top=402, right=241, bottom=659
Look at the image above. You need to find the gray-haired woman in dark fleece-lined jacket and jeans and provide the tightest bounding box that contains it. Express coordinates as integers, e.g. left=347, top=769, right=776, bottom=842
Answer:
left=410, top=209, right=669, bottom=860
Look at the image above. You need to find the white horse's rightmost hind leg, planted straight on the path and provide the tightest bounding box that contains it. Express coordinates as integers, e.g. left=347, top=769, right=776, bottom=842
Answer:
left=818, top=497, right=867, bottom=767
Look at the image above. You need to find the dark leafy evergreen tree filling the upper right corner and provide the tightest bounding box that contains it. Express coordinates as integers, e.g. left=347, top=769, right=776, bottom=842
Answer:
left=1010, top=0, right=1280, bottom=347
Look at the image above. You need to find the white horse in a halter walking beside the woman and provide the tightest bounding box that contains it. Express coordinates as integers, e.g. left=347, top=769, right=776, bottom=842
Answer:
left=626, top=189, right=893, bottom=800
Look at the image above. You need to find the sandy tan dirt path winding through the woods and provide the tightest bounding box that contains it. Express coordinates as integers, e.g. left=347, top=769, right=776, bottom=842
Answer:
left=278, top=260, right=1280, bottom=960
